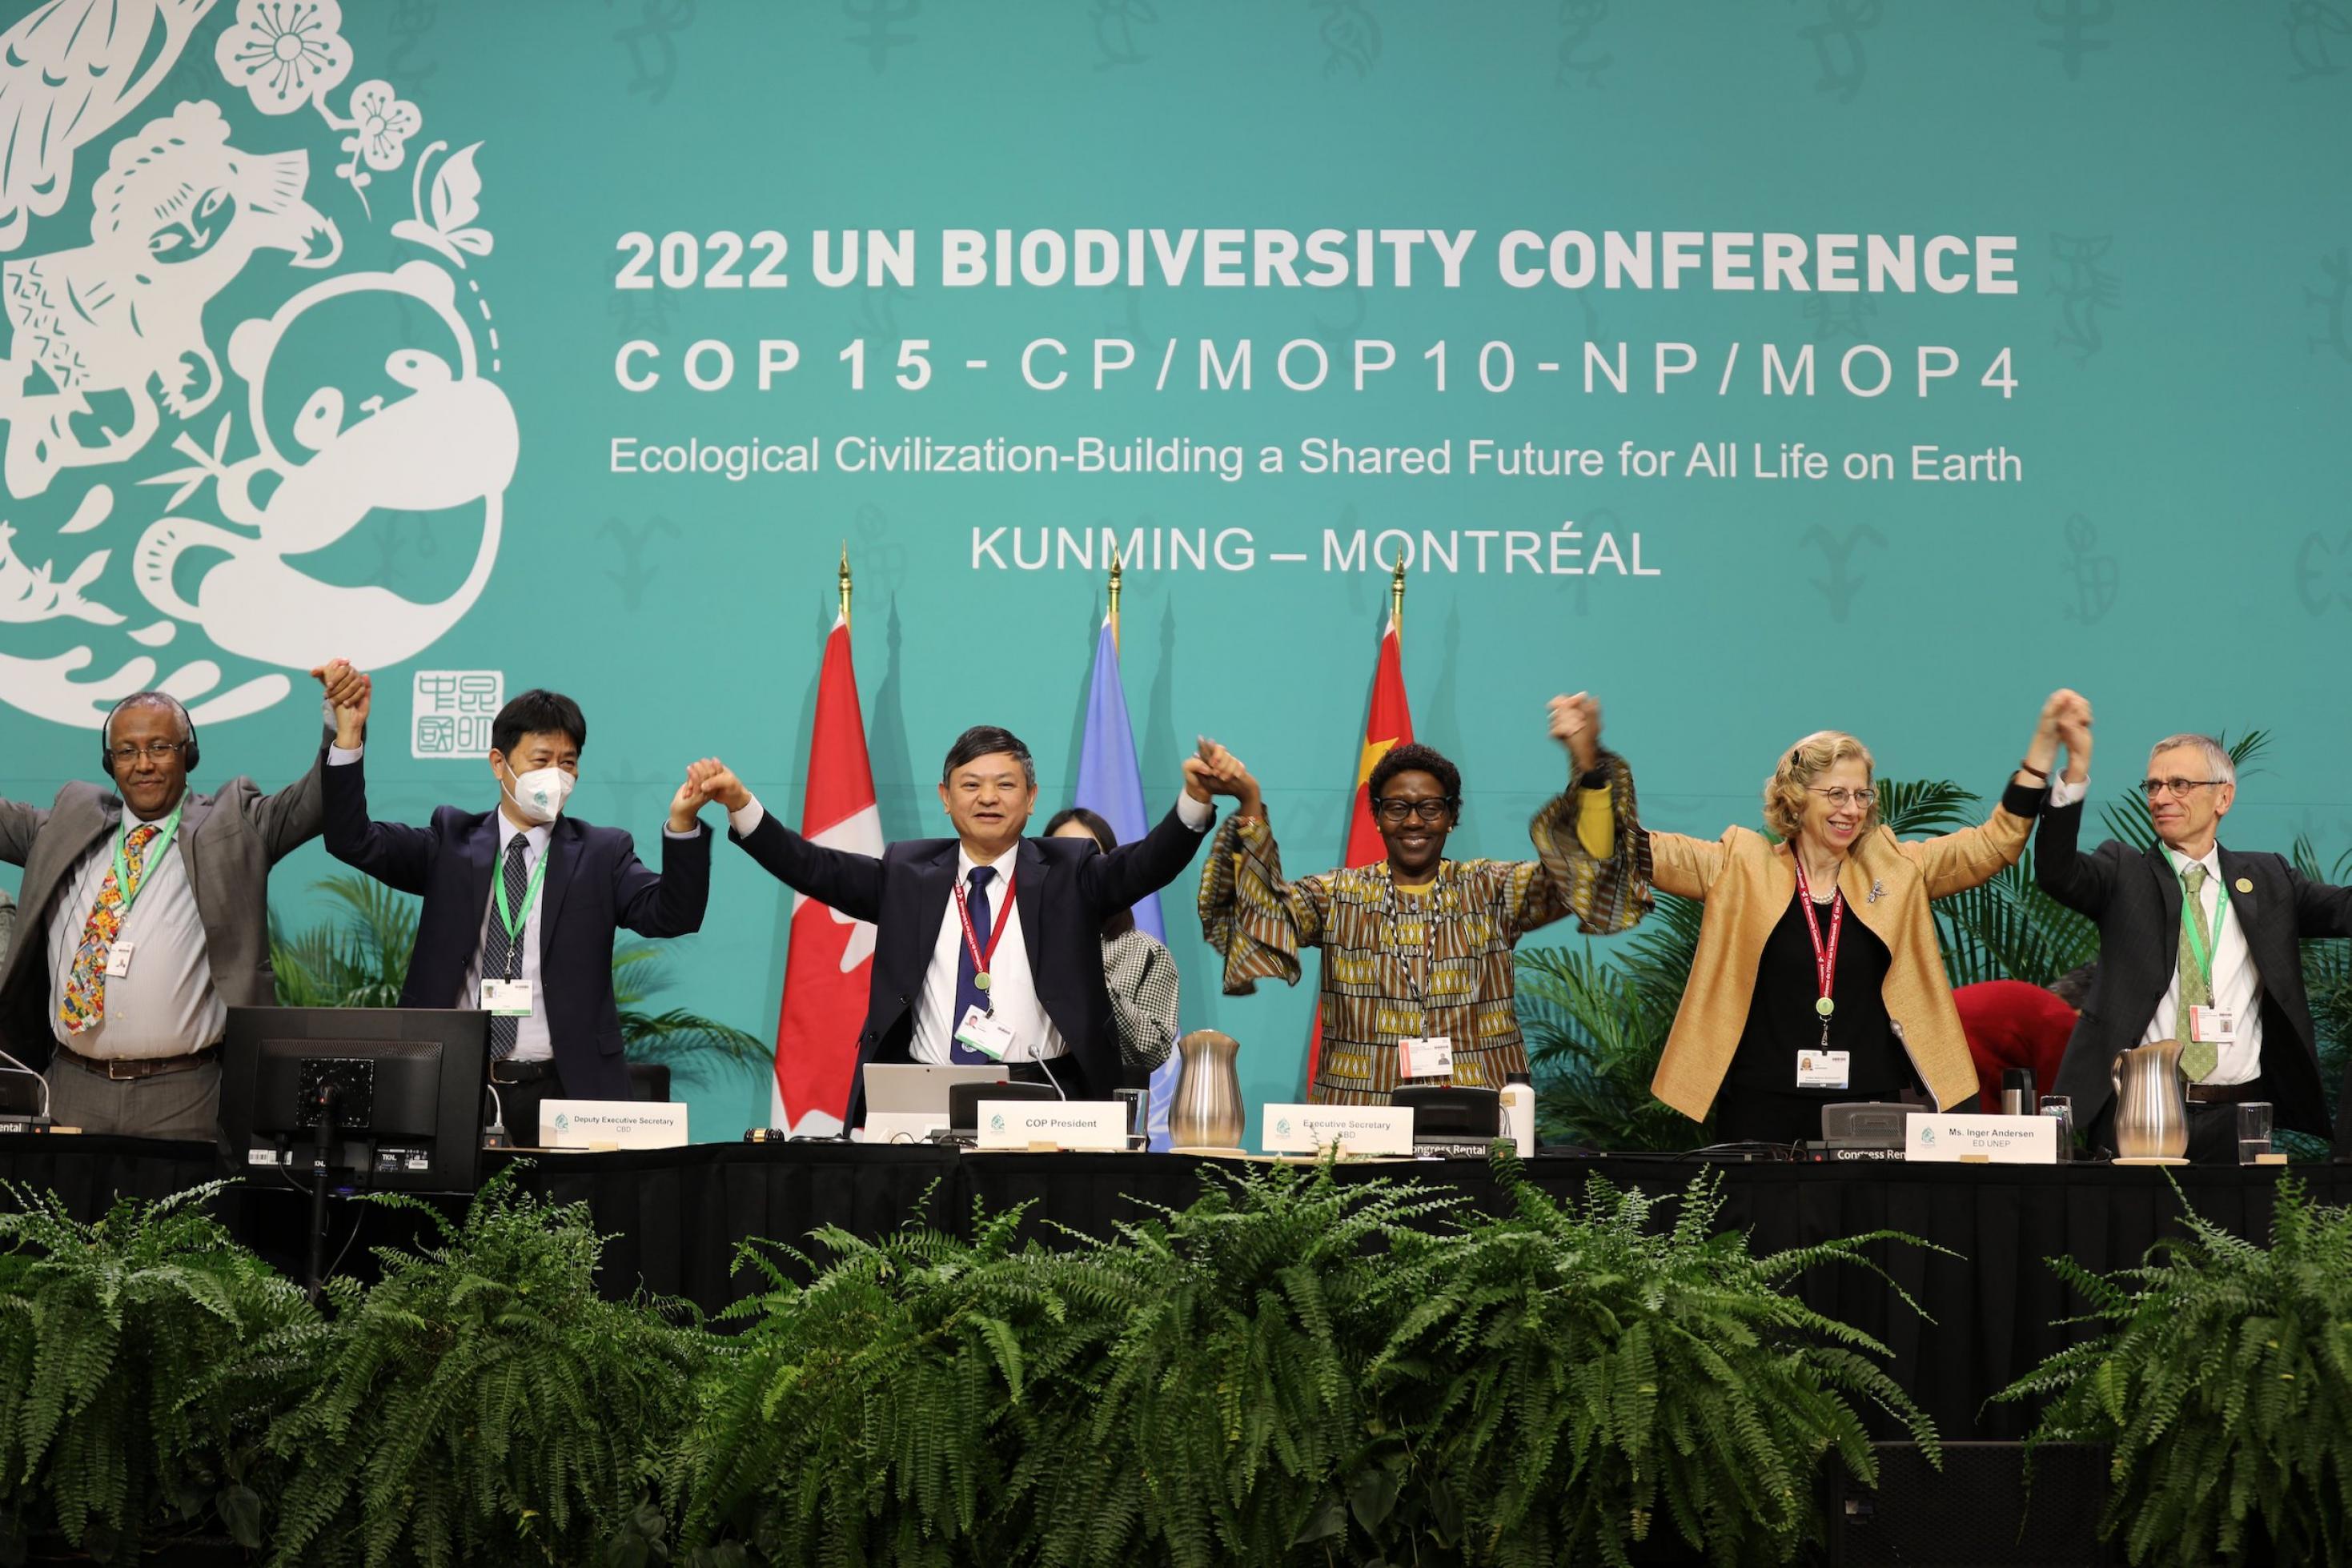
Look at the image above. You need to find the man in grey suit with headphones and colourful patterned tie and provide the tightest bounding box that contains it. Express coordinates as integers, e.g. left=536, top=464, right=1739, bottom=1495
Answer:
left=0, top=691, right=324, bottom=1138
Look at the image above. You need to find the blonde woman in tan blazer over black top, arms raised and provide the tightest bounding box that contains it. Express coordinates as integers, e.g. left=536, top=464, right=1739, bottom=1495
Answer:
left=1647, top=691, right=2089, bottom=1142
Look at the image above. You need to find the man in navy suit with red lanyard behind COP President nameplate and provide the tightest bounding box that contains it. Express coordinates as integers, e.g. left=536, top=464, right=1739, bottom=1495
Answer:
left=689, top=724, right=1233, bottom=1124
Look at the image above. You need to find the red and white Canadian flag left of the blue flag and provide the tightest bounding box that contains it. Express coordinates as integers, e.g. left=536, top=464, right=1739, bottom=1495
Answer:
left=769, top=616, right=882, bottom=1138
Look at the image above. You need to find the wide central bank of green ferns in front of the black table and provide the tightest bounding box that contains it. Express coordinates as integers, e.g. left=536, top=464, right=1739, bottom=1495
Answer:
left=670, top=1166, right=1936, bottom=1568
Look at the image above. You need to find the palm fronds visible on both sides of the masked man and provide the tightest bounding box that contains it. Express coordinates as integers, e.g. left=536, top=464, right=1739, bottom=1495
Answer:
left=271, top=877, right=769, bottom=1084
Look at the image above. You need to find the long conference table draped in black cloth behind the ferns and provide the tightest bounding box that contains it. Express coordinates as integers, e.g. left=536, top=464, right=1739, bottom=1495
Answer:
left=0, top=1136, right=2352, bottom=1438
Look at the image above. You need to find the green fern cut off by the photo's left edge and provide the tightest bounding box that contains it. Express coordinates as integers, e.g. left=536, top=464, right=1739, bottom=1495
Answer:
left=0, top=1182, right=315, bottom=1563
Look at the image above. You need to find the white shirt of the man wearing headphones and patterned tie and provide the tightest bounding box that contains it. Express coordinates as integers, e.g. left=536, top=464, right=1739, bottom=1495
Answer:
left=50, top=823, right=228, bottom=1061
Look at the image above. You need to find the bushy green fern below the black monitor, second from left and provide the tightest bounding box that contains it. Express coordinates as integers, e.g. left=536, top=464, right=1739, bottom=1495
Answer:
left=254, top=1173, right=722, bottom=1568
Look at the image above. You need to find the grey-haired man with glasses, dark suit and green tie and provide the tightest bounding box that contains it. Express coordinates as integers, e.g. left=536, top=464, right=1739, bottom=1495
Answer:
left=2034, top=712, right=2352, bottom=1164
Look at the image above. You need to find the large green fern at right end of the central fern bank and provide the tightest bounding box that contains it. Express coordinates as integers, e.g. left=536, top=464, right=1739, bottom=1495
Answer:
left=1367, top=1161, right=1938, bottom=1568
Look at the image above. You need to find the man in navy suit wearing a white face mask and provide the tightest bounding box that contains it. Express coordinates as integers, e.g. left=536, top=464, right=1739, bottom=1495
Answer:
left=313, top=660, right=710, bottom=1140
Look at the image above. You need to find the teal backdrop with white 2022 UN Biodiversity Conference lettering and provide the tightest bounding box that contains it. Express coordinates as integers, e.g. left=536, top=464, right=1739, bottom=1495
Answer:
left=0, top=0, right=2352, bottom=1138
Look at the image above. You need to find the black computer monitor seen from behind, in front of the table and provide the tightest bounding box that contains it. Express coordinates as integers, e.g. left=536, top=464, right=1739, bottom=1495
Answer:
left=221, top=1006, right=489, bottom=1192
